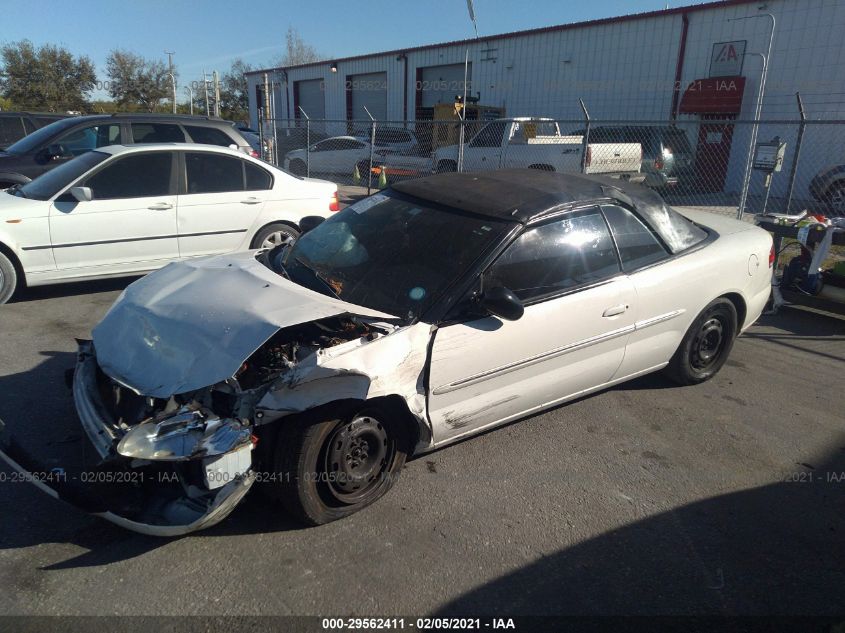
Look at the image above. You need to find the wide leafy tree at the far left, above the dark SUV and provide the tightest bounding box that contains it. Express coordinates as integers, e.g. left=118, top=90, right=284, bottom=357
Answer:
left=0, top=40, right=97, bottom=112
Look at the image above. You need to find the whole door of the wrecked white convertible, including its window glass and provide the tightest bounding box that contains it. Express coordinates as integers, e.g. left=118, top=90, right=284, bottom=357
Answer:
left=429, top=207, right=636, bottom=443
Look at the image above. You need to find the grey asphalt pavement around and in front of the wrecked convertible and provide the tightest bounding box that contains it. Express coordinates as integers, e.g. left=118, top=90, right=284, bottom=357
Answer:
left=0, top=252, right=845, bottom=616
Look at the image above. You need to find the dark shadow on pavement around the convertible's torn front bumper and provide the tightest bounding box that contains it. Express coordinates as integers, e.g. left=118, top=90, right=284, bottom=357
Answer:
left=0, top=352, right=301, bottom=570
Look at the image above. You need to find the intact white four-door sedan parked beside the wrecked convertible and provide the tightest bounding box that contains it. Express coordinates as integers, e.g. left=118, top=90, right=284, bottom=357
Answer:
left=0, top=143, right=338, bottom=304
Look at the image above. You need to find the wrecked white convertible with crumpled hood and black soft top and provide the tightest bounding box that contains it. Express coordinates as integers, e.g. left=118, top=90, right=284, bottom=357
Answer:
left=3, top=170, right=772, bottom=535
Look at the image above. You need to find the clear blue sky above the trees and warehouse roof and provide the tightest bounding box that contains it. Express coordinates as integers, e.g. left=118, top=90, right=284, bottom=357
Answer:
left=0, top=0, right=684, bottom=97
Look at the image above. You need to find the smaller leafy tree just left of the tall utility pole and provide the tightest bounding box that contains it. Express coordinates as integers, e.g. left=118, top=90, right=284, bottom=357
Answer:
left=106, top=50, right=176, bottom=112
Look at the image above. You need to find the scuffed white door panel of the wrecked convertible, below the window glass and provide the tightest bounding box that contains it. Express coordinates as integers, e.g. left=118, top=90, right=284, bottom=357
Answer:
left=429, top=275, right=636, bottom=444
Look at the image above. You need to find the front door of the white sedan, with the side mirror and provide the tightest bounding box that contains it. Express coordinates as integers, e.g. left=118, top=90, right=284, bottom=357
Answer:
left=50, top=151, right=179, bottom=273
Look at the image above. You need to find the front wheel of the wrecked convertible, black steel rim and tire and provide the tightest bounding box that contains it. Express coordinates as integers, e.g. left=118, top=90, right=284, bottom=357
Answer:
left=275, top=409, right=408, bottom=525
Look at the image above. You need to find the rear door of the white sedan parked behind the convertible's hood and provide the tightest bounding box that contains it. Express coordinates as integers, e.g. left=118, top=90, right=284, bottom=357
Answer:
left=172, top=152, right=262, bottom=257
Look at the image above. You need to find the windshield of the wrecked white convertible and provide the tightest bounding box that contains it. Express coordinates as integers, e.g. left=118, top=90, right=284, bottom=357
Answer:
left=284, top=193, right=513, bottom=320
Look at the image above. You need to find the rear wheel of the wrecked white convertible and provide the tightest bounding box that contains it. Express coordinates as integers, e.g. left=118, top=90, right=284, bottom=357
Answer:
left=664, top=297, right=737, bottom=385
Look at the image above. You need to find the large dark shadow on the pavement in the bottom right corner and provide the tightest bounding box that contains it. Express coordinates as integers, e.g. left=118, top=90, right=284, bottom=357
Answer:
left=438, top=435, right=845, bottom=617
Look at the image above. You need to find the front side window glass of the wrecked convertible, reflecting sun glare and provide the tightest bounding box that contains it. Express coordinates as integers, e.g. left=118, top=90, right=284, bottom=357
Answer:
left=484, top=207, right=620, bottom=301
